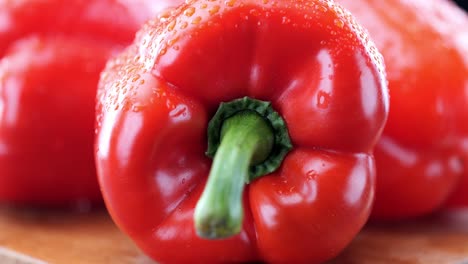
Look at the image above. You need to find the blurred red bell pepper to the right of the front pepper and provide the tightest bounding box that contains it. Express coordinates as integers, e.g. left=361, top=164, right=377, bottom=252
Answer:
left=338, top=0, right=468, bottom=220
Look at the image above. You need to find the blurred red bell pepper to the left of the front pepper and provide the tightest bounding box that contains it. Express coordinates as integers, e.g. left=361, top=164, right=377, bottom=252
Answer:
left=0, top=0, right=173, bottom=206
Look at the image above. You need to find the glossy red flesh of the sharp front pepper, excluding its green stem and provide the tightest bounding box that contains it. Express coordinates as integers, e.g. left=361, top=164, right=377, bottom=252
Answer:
left=96, top=0, right=388, bottom=263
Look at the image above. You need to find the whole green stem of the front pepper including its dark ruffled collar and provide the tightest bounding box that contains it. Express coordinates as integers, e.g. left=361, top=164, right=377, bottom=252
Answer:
left=194, top=97, right=292, bottom=239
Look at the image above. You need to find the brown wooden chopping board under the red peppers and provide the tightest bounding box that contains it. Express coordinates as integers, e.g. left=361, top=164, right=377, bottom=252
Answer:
left=0, top=207, right=468, bottom=264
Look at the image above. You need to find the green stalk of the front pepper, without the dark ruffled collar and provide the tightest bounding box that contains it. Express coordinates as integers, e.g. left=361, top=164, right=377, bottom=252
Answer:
left=195, top=110, right=275, bottom=239
